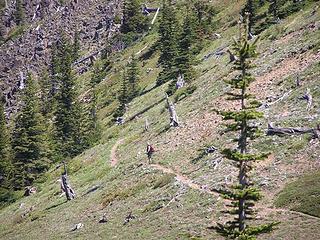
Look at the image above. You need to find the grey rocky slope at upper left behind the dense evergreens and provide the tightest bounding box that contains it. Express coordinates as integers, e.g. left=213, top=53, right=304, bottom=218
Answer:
left=0, top=0, right=122, bottom=115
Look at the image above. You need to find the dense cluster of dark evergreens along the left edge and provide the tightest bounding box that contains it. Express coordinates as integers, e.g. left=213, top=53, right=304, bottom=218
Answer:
left=0, top=31, right=99, bottom=201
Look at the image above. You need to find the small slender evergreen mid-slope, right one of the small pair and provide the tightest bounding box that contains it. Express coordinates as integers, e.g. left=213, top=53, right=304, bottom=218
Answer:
left=127, top=56, right=139, bottom=101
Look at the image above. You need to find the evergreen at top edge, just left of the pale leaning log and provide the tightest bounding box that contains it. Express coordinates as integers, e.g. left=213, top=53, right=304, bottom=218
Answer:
left=120, top=0, right=148, bottom=34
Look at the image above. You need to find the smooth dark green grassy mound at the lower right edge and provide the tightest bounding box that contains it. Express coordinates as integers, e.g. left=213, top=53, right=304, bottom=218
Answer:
left=275, top=172, right=320, bottom=217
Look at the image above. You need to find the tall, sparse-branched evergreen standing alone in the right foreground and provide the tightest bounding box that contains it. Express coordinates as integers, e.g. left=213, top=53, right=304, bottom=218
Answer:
left=217, top=18, right=275, bottom=239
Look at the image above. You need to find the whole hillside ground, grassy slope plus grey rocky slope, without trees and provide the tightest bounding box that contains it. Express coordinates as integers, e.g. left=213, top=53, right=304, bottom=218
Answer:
left=0, top=0, right=320, bottom=240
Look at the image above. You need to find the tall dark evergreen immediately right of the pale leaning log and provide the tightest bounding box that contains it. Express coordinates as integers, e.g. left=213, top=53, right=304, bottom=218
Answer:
left=157, top=0, right=179, bottom=86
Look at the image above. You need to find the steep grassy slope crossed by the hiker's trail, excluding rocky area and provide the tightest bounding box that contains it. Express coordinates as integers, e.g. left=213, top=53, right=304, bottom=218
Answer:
left=0, top=1, right=320, bottom=239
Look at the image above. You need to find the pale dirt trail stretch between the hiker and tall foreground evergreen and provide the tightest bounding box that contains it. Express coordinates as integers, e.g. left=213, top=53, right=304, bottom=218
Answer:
left=150, top=164, right=219, bottom=196
